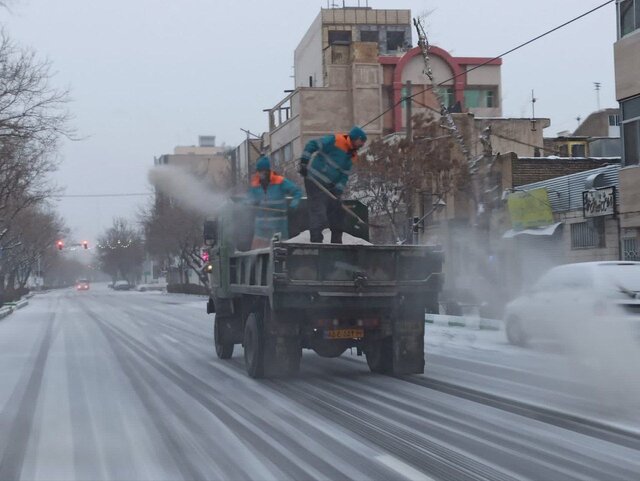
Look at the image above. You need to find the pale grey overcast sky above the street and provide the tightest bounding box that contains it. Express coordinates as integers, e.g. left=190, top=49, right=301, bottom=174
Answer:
left=0, top=0, right=617, bottom=242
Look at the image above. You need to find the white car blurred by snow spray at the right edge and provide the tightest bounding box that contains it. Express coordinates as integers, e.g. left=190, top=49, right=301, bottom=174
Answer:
left=504, top=261, right=640, bottom=346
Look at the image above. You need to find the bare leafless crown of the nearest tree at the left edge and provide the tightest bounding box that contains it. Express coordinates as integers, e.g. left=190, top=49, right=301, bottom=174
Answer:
left=0, top=32, right=72, bottom=241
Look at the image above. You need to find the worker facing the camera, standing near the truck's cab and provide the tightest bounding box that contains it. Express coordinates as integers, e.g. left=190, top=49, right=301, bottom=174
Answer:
left=247, top=156, right=302, bottom=249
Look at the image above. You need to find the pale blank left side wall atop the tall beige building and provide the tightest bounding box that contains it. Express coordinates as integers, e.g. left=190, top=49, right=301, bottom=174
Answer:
left=293, top=14, right=324, bottom=87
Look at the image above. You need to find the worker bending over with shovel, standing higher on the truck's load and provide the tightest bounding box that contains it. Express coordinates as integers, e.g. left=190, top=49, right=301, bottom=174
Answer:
left=299, top=126, right=367, bottom=244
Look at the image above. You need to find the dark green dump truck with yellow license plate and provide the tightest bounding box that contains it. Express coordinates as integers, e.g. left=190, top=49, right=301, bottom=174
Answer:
left=205, top=199, right=443, bottom=378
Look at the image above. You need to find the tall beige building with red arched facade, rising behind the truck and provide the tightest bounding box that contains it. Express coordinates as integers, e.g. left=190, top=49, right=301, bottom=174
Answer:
left=266, top=7, right=502, bottom=173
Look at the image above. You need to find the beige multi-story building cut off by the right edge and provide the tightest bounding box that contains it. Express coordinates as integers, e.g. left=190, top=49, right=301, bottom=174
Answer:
left=614, top=0, right=640, bottom=260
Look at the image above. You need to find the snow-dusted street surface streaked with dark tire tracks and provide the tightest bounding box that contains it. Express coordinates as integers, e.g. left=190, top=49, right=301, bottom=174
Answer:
left=0, top=285, right=640, bottom=481
